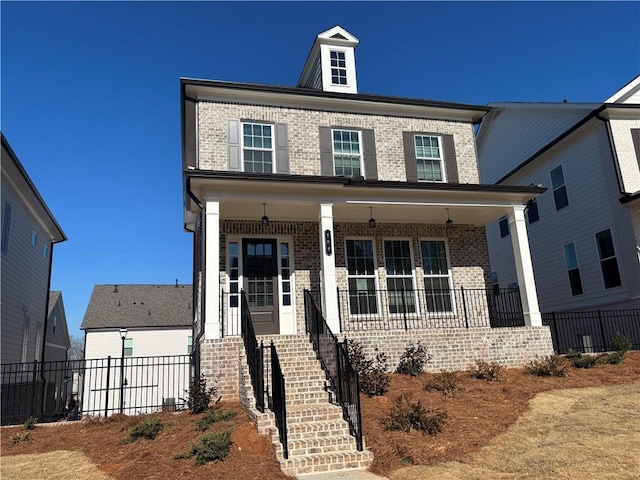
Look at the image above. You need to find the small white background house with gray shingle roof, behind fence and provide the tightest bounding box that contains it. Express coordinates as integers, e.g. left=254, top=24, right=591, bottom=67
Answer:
left=80, top=283, right=193, bottom=415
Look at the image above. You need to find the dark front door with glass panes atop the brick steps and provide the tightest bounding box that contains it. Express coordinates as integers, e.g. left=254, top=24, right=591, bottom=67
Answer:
left=242, top=238, right=280, bottom=335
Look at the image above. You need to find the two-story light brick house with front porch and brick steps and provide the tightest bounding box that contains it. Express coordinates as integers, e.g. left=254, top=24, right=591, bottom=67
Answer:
left=180, top=26, right=551, bottom=474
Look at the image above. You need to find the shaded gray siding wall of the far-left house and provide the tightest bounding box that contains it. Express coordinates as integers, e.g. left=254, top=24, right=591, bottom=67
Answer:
left=0, top=180, right=52, bottom=363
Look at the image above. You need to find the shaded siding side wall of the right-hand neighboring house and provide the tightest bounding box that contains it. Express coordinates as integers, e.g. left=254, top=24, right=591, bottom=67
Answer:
left=487, top=121, right=640, bottom=312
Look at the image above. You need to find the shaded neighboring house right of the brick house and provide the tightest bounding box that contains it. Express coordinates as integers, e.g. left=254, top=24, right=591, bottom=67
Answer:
left=477, top=76, right=640, bottom=312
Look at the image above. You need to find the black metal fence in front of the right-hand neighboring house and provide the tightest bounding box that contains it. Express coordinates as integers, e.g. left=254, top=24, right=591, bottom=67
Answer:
left=542, top=309, right=640, bottom=354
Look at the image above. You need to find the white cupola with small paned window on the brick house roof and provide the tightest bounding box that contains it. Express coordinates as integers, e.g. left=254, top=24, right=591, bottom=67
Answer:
left=298, top=25, right=360, bottom=93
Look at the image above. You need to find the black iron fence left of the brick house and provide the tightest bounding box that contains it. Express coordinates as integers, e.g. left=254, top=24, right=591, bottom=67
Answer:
left=2, top=355, right=191, bottom=425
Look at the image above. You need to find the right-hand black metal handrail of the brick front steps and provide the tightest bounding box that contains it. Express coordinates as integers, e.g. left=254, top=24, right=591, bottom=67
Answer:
left=304, top=290, right=363, bottom=451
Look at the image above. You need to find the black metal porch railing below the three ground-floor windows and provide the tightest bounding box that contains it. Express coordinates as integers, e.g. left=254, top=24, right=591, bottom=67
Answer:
left=338, top=287, right=524, bottom=331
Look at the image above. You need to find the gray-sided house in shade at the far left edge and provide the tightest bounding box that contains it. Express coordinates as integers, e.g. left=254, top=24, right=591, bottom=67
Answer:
left=0, top=134, right=67, bottom=423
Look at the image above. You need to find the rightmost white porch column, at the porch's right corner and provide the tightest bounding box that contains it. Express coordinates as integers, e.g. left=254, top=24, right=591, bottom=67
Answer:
left=509, top=205, right=542, bottom=327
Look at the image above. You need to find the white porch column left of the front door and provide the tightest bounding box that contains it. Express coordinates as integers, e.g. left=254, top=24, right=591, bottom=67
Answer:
left=204, top=198, right=220, bottom=339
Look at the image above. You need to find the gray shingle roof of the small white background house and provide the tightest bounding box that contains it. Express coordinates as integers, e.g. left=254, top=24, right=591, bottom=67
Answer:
left=80, top=285, right=193, bottom=330
